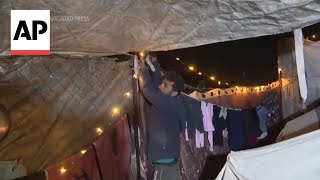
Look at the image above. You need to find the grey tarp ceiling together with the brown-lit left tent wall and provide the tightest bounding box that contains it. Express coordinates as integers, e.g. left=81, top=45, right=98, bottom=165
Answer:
left=0, top=0, right=320, bottom=179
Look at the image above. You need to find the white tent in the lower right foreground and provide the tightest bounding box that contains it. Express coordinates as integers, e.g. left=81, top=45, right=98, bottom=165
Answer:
left=216, top=130, right=320, bottom=180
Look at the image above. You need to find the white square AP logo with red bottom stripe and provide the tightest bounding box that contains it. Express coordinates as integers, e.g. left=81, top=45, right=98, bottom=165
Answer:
left=11, top=10, right=50, bottom=55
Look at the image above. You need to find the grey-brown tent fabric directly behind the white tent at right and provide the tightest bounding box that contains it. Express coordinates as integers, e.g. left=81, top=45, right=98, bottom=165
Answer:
left=276, top=107, right=320, bottom=142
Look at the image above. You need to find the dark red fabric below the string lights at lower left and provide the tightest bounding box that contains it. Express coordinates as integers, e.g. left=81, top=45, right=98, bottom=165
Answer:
left=47, top=116, right=131, bottom=180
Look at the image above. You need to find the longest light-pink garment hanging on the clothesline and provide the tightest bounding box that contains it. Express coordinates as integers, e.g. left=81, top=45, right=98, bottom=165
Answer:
left=201, top=101, right=214, bottom=152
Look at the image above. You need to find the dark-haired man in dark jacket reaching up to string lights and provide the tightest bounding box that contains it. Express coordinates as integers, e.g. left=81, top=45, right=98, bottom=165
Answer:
left=139, top=52, right=185, bottom=180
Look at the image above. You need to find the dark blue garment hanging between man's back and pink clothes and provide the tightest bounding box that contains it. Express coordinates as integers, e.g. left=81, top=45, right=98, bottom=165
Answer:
left=181, top=94, right=204, bottom=137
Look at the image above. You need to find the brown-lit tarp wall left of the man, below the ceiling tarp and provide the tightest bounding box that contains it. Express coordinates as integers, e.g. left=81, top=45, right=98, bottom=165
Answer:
left=0, top=56, right=133, bottom=174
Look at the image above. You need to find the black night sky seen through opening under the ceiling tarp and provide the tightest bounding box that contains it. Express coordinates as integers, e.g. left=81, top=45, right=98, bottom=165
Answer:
left=158, top=23, right=320, bottom=88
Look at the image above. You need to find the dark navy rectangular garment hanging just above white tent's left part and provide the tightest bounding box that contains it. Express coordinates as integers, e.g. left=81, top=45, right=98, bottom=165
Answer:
left=227, top=109, right=245, bottom=151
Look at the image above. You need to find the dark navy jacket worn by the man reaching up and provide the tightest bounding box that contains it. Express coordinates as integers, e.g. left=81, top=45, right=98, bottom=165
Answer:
left=139, top=61, right=185, bottom=162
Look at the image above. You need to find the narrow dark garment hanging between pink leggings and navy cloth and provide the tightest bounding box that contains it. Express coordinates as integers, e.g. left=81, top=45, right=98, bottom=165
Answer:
left=212, top=106, right=227, bottom=146
